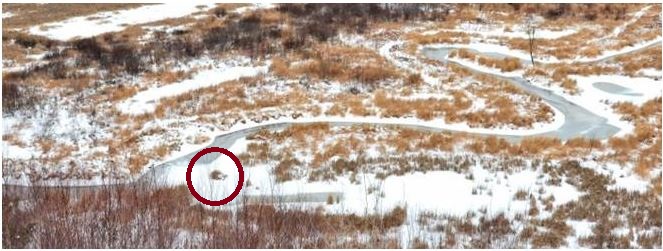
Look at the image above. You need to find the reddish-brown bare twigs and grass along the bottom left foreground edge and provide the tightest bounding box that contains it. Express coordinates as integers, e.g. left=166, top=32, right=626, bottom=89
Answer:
left=2, top=185, right=407, bottom=248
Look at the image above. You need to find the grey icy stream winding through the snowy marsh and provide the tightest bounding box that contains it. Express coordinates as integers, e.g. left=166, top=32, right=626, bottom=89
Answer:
left=3, top=42, right=640, bottom=202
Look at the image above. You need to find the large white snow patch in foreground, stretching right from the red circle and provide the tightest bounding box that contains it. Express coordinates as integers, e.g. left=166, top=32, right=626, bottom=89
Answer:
left=160, top=128, right=580, bottom=217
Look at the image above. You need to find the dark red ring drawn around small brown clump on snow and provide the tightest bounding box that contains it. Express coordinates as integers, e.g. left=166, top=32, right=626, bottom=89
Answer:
left=186, top=147, right=244, bottom=206
